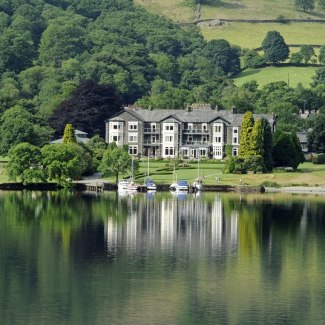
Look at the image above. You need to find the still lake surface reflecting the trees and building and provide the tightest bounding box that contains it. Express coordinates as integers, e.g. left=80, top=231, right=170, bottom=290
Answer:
left=0, top=192, right=325, bottom=325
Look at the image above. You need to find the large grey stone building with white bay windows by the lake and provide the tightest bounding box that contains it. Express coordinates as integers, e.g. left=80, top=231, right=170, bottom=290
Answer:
left=105, top=105, right=275, bottom=159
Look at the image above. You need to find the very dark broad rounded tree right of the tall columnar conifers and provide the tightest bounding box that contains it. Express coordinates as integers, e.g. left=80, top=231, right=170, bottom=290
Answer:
left=272, top=131, right=304, bottom=169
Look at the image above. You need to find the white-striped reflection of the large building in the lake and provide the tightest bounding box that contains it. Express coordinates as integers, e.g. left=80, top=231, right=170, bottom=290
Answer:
left=105, top=194, right=238, bottom=255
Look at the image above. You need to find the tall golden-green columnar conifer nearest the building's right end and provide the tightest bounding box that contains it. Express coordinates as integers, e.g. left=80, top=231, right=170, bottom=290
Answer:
left=239, top=112, right=255, bottom=157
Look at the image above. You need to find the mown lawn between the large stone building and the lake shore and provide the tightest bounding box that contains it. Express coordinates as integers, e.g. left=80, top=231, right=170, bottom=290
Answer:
left=107, top=161, right=325, bottom=186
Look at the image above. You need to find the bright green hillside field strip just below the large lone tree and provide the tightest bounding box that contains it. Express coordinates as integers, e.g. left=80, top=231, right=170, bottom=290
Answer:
left=233, top=67, right=316, bottom=88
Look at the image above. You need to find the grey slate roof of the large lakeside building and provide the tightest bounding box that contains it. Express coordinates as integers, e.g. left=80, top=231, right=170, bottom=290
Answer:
left=124, top=107, right=274, bottom=126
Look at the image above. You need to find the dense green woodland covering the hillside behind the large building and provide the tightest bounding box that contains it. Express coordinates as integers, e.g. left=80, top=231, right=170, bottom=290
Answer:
left=0, top=0, right=325, bottom=163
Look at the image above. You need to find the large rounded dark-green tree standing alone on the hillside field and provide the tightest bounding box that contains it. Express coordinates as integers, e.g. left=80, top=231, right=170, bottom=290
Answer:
left=262, top=31, right=289, bottom=63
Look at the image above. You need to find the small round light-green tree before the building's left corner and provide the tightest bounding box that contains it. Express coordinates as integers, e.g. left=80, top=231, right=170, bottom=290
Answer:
left=99, top=143, right=131, bottom=183
